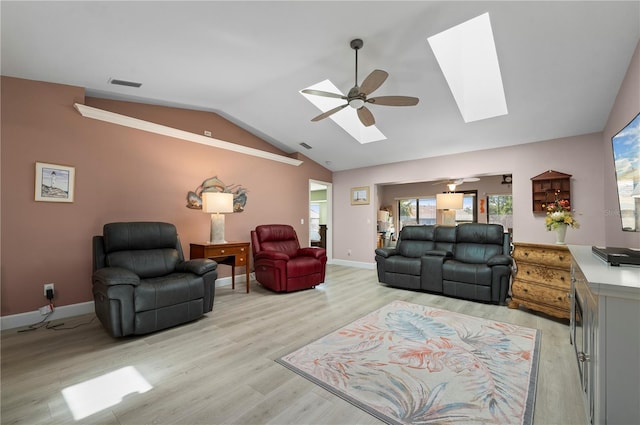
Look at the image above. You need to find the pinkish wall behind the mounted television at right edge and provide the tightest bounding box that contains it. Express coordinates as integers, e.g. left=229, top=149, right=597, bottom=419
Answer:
left=602, top=39, right=640, bottom=248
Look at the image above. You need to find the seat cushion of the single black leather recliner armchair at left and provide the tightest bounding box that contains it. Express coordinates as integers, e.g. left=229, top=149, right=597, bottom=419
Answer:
left=134, top=273, right=204, bottom=313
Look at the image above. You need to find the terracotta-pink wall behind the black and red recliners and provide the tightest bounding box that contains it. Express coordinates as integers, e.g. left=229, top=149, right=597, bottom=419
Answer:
left=0, top=77, right=332, bottom=316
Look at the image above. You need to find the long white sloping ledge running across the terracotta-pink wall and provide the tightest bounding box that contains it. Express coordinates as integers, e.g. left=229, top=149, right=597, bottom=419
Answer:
left=73, top=103, right=302, bottom=166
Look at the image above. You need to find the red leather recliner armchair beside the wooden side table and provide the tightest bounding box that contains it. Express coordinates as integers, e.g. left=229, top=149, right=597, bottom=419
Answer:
left=251, top=224, right=327, bottom=292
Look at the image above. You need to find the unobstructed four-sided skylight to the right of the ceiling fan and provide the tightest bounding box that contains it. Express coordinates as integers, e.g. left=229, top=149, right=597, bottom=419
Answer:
left=428, top=13, right=508, bottom=123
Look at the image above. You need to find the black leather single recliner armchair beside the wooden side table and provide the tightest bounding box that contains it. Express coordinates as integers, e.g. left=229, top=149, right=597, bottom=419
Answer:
left=92, top=222, right=218, bottom=337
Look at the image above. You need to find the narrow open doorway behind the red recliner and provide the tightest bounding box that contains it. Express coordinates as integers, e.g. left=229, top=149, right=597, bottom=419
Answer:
left=307, top=179, right=333, bottom=261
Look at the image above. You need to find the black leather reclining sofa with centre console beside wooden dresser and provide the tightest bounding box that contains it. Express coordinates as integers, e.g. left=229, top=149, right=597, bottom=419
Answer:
left=375, top=223, right=513, bottom=304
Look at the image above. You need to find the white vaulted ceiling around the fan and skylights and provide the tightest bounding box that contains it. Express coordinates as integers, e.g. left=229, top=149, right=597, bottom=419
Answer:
left=0, top=1, right=640, bottom=171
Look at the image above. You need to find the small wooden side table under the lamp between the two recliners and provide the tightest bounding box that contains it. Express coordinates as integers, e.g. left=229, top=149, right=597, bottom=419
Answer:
left=189, top=242, right=250, bottom=294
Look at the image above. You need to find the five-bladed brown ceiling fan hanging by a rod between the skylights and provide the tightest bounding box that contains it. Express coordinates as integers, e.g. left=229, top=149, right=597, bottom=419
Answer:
left=302, top=38, right=419, bottom=127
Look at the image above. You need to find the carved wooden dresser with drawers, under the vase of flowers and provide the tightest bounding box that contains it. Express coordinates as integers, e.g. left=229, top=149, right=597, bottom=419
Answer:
left=509, top=242, right=571, bottom=319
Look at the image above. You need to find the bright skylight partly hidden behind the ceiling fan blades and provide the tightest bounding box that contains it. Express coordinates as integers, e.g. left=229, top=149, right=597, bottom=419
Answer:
left=300, top=80, right=386, bottom=144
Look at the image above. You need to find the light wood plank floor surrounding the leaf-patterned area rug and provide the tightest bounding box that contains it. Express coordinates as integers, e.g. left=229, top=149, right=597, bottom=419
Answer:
left=1, top=265, right=586, bottom=425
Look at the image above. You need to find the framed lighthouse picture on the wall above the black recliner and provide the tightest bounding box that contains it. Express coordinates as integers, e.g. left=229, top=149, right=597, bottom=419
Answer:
left=35, top=162, right=76, bottom=202
